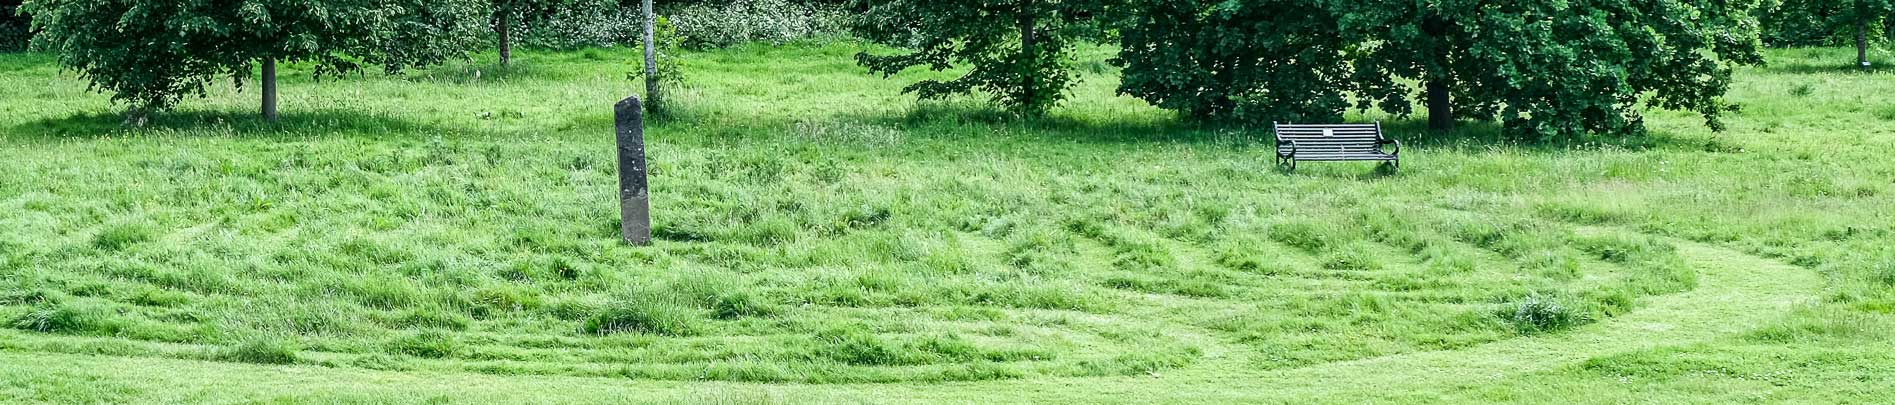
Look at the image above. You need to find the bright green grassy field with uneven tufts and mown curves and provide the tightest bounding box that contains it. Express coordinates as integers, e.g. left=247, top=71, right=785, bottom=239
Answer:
left=0, top=44, right=1895, bottom=403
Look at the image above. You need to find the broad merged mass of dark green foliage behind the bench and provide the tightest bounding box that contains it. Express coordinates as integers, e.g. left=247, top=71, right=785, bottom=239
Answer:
left=1120, top=0, right=1762, bottom=138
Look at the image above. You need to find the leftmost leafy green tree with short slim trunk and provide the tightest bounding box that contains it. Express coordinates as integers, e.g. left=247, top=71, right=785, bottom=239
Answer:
left=25, top=0, right=481, bottom=123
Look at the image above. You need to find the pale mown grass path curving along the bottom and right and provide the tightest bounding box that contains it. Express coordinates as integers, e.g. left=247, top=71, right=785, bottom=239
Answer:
left=0, top=229, right=1823, bottom=403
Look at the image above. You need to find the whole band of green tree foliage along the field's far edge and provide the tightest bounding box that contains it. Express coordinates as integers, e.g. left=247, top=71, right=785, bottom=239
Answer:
left=11, top=0, right=1834, bottom=138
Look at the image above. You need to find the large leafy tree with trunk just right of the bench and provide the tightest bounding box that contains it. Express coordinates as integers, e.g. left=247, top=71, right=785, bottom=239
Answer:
left=1338, top=0, right=1762, bottom=138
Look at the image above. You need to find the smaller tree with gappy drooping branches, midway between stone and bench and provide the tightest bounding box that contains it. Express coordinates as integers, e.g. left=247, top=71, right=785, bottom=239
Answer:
left=857, top=0, right=1099, bottom=115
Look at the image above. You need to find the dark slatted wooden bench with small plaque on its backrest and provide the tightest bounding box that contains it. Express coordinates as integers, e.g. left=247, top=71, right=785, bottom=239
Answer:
left=1273, top=123, right=1402, bottom=170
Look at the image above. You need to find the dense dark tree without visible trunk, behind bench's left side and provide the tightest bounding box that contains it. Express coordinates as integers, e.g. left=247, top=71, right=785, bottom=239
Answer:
left=1112, top=0, right=1353, bottom=123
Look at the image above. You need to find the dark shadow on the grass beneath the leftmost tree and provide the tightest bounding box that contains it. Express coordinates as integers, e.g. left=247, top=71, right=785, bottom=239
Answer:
left=6, top=110, right=495, bottom=140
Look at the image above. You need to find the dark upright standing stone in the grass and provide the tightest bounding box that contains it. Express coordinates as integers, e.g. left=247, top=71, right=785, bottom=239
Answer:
left=612, top=97, right=652, bottom=246
